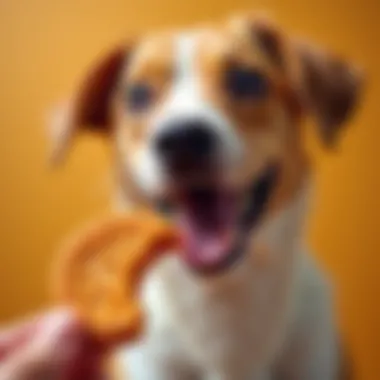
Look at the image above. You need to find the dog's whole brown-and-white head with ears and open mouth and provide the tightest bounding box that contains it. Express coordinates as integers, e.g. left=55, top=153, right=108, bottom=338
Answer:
left=49, top=15, right=361, bottom=269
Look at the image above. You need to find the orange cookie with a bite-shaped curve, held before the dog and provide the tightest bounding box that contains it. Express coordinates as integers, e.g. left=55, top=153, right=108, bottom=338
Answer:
left=54, top=212, right=178, bottom=343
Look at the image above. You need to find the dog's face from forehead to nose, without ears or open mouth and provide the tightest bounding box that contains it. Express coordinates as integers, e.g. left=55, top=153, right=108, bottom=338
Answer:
left=115, top=25, right=294, bottom=198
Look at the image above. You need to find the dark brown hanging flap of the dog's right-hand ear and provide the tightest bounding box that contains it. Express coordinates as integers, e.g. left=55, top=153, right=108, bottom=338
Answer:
left=294, top=41, right=364, bottom=146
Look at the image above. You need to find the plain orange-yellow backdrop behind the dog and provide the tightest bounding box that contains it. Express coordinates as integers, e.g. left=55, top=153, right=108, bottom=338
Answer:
left=0, top=0, right=380, bottom=380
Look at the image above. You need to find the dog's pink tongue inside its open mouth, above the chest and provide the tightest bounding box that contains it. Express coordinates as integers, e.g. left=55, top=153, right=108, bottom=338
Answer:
left=177, top=193, right=236, bottom=268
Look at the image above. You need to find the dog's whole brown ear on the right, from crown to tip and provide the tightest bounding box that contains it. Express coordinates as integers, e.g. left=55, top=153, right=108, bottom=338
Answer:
left=246, top=15, right=363, bottom=146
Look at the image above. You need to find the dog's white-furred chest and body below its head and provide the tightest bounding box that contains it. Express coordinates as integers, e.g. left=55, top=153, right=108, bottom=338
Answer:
left=115, top=180, right=336, bottom=380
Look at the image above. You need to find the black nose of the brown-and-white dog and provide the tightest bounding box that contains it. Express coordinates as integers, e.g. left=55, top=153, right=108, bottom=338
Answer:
left=156, top=119, right=217, bottom=161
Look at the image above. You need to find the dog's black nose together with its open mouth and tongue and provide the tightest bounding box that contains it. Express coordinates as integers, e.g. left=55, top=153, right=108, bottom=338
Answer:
left=154, top=116, right=277, bottom=274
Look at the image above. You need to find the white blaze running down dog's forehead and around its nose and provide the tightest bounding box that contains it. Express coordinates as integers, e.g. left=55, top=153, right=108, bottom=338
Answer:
left=132, top=32, right=242, bottom=195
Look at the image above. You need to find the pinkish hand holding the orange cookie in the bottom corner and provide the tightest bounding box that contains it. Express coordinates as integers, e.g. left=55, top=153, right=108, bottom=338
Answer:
left=0, top=309, right=106, bottom=380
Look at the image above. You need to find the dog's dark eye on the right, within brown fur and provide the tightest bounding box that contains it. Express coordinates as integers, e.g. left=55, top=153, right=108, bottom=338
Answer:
left=225, top=65, right=269, bottom=100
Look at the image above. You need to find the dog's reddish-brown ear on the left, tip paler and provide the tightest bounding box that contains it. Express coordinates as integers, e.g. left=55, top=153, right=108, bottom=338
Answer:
left=49, top=45, right=131, bottom=165
